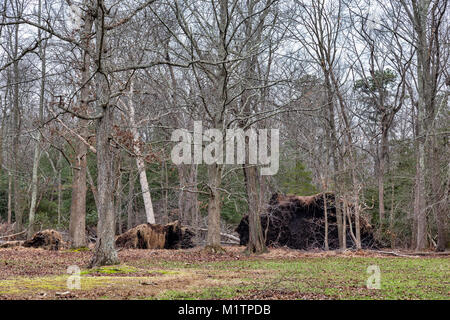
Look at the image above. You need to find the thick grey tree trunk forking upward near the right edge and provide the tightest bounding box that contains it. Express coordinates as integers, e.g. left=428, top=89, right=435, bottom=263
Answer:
left=400, top=0, right=447, bottom=251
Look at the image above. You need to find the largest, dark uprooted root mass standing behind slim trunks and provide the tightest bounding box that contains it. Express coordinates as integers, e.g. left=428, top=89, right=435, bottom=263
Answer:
left=236, top=193, right=376, bottom=250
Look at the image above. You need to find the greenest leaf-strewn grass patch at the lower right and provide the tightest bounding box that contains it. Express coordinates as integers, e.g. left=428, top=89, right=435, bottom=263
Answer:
left=201, top=257, right=450, bottom=299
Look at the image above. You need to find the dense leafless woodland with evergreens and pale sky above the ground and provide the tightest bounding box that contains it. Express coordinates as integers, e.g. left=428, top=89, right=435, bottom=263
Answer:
left=0, top=0, right=450, bottom=265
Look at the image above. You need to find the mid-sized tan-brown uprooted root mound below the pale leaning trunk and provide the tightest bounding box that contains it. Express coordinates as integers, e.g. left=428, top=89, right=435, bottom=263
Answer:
left=116, top=221, right=195, bottom=249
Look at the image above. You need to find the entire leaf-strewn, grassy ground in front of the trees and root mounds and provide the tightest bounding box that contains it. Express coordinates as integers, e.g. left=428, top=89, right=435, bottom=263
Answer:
left=0, top=246, right=450, bottom=300
